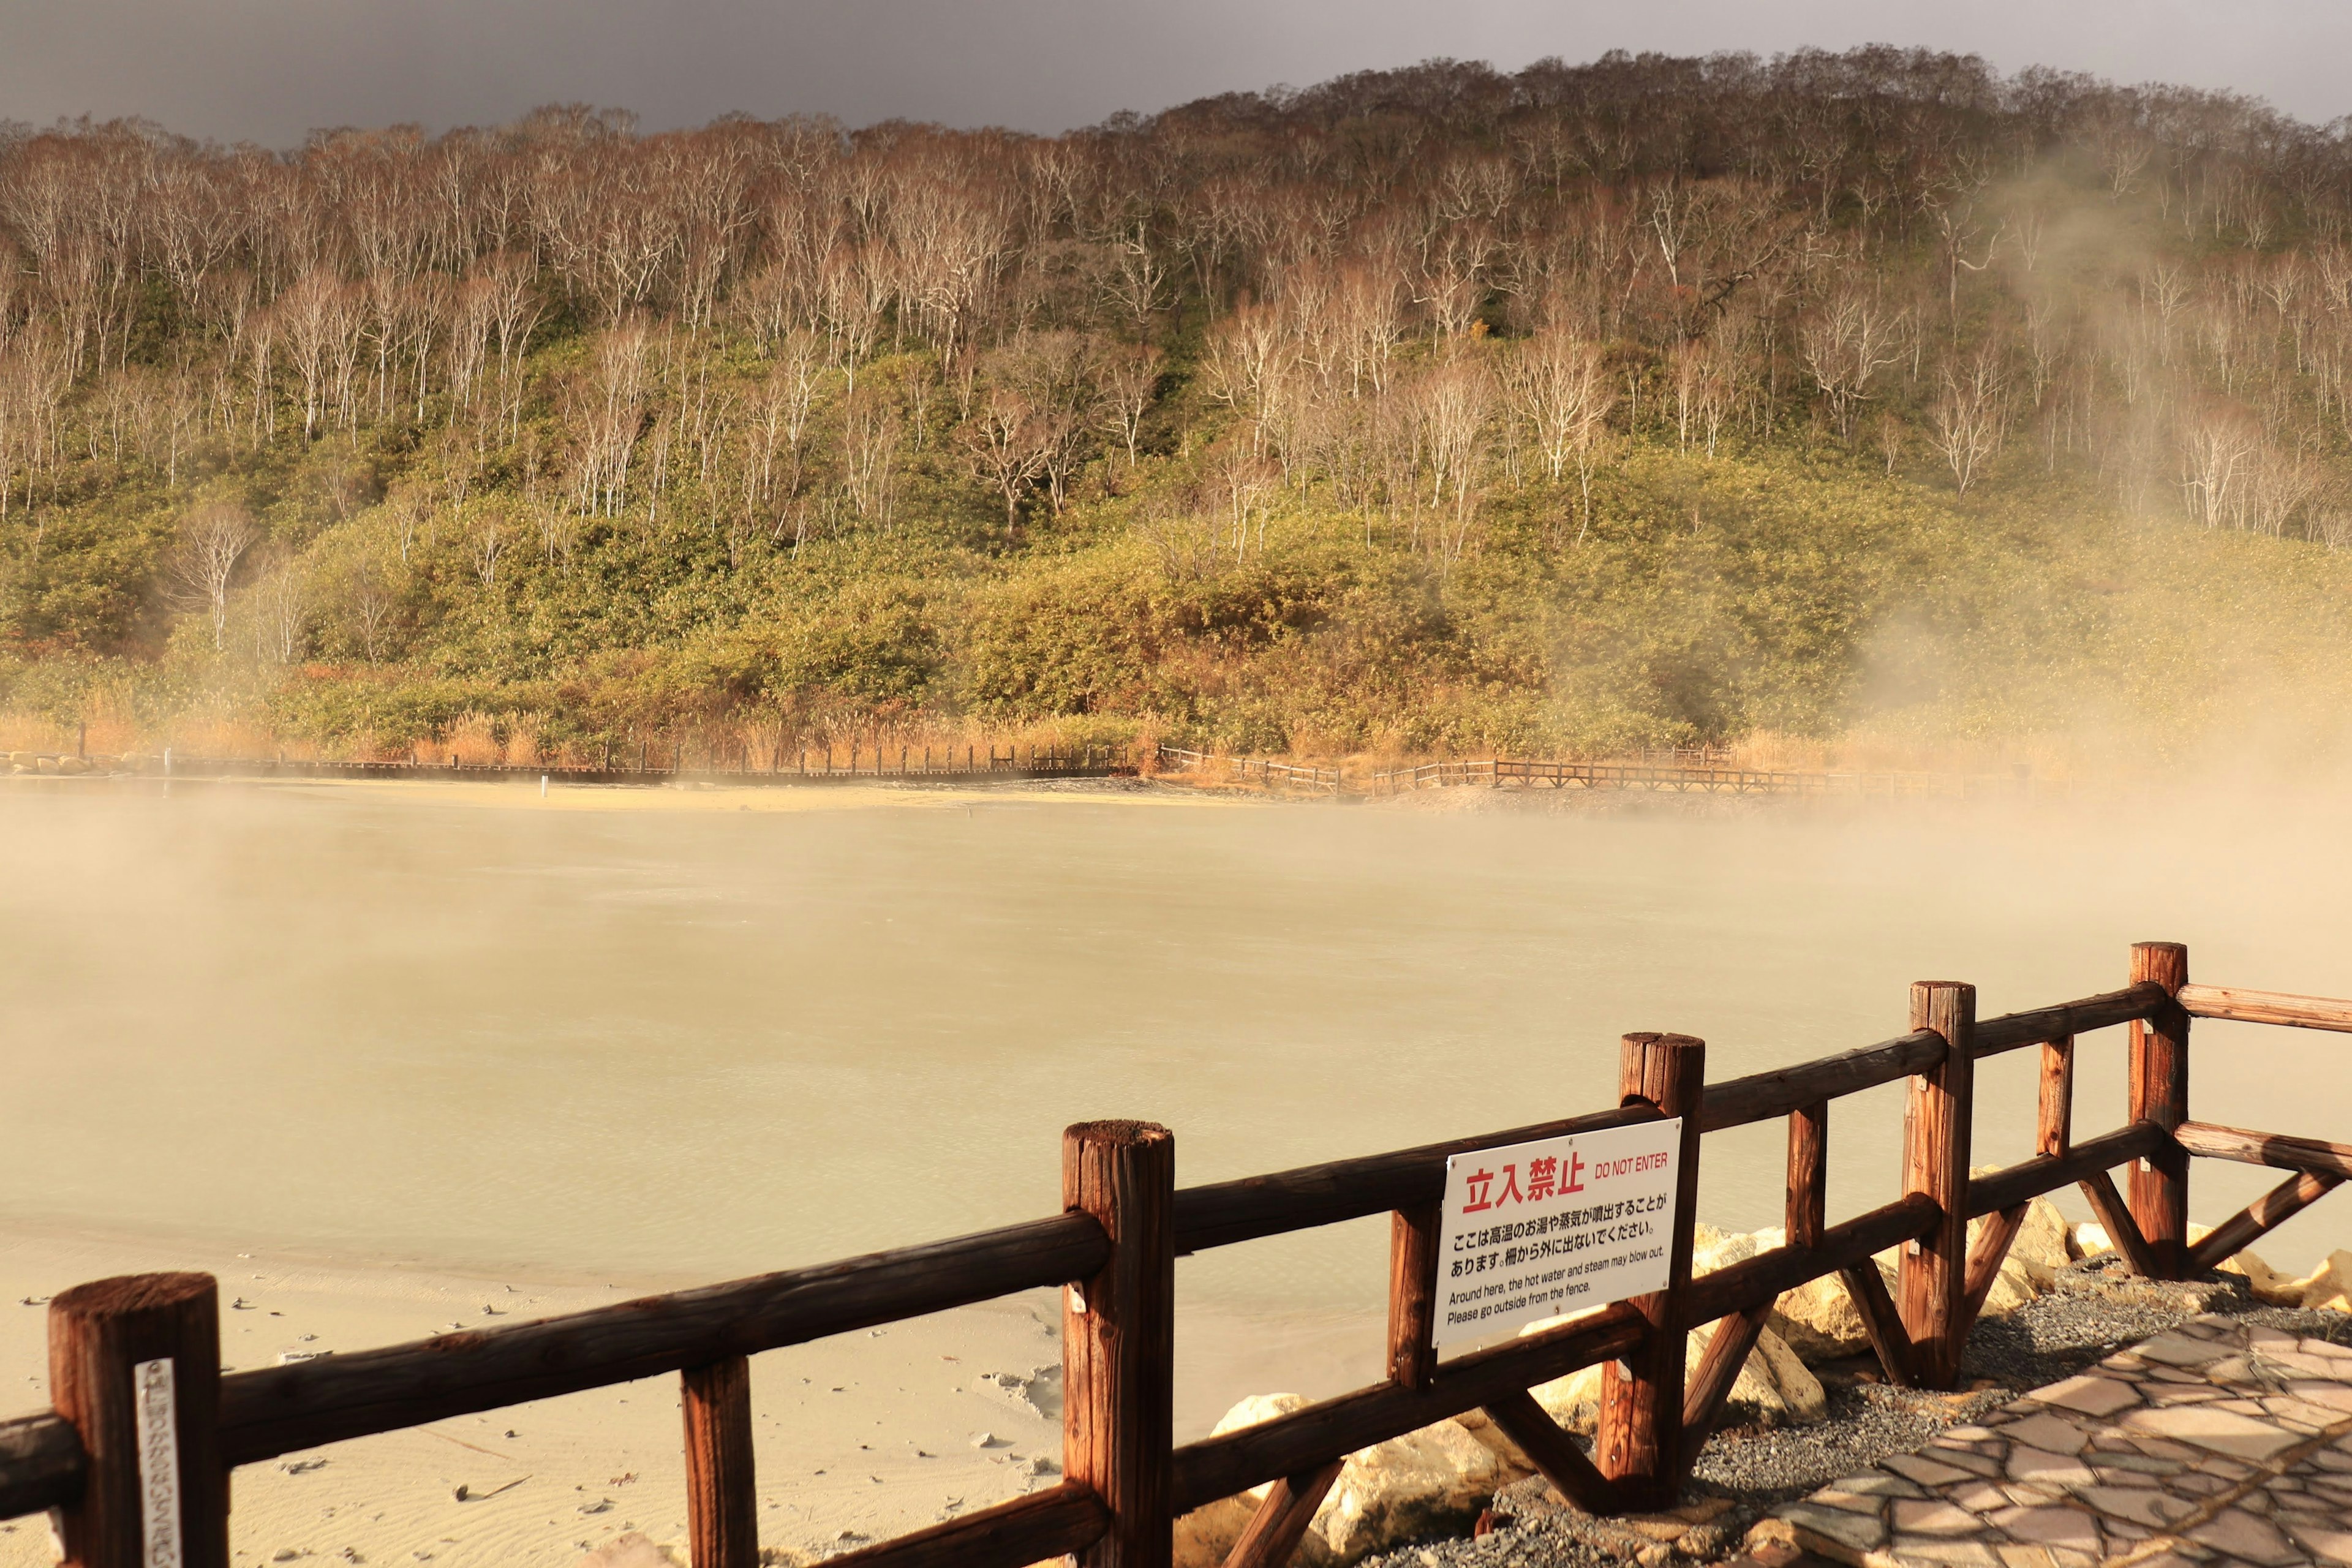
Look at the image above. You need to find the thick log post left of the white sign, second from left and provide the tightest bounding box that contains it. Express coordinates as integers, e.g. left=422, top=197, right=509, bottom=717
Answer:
left=1061, top=1121, right=1176, bottom=1568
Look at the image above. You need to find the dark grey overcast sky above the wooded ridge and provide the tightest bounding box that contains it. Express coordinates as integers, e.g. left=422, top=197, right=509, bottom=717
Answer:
left=0, top=0, right=2352, bottom=146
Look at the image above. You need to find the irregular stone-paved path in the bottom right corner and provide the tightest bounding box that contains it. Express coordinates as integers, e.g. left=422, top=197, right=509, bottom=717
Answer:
left=1750, top=1316, right=2352, bottom=1568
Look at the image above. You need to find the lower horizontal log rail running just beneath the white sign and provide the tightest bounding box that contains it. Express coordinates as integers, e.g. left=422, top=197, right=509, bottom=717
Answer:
left=1174, top=1302, right=1644, bottom=1514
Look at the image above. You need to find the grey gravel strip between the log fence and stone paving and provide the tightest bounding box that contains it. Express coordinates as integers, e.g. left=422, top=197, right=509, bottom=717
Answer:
left=1366, top=1257, right=2352, bottom=1568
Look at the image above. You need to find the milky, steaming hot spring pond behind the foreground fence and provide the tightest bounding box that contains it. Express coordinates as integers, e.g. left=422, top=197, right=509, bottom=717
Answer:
left=0, top=788, right=2352, bottom=1314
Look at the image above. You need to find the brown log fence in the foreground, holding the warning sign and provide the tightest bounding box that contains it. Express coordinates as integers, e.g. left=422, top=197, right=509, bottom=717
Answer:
left=0, top=943, right=2352, bottom=1568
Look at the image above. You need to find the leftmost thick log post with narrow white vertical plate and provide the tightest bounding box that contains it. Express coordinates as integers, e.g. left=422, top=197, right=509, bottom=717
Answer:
left=50, top=1274, right=228, bottom=1568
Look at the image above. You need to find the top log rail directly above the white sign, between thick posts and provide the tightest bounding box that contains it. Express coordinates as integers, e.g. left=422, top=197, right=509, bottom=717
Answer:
left=1176, top=1105, right=1658, bottom=1260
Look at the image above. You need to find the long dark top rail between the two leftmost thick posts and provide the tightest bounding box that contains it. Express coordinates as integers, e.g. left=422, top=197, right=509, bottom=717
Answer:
left=221, top=1213, right=1110, bottom=1464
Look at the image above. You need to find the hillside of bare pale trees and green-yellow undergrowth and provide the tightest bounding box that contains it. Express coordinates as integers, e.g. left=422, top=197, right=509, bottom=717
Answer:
left=0, top=50, right=2352, bottom=757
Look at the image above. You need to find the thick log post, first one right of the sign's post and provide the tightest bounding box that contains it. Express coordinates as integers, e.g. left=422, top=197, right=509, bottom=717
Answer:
left=1865, top=980, right=1976, bottom=1389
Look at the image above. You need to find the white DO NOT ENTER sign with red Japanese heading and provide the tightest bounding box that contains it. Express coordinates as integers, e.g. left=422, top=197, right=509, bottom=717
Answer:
left=1434, top=1119, right=1682, bottom=1349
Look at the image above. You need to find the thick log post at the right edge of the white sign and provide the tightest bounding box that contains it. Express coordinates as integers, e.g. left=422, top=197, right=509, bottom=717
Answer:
left=1593, top=1035, right=1708, bottom=1509
